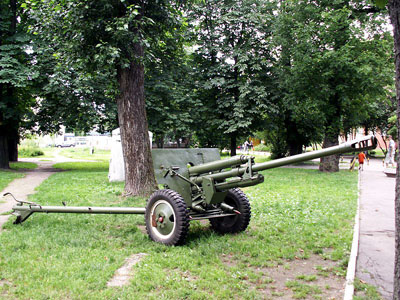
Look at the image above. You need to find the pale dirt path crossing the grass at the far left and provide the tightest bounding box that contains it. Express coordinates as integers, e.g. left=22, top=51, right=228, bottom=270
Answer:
left=0, top=161, right=60, bottom=231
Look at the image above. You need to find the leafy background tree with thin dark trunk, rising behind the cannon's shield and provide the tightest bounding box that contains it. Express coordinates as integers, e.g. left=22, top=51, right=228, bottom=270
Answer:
left=190, top=0, right=274, bottom=155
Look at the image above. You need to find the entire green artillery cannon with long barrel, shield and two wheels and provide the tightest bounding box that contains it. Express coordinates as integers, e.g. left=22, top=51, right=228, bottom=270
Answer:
left=13, top=136, right=376, bottom=245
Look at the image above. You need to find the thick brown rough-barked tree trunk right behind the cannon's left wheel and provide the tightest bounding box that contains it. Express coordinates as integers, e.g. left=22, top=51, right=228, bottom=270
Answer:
left=117, top=43, right=157, bottom=196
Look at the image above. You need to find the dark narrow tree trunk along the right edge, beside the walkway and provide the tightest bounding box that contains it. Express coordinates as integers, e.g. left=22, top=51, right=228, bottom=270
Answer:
left=388, top=0, right=400, bottom=300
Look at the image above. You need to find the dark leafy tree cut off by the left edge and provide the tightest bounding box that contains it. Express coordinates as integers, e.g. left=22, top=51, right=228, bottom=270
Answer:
left=0, top=0, right=37, bottom=168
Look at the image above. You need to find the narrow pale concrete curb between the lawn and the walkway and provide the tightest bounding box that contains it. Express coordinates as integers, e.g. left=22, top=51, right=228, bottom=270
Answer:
left=343, top=171, right=361, bottom=300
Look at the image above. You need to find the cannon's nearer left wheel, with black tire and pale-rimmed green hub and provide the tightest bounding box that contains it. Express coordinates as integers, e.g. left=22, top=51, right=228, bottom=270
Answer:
left=145, top=189, right=189, bottom=246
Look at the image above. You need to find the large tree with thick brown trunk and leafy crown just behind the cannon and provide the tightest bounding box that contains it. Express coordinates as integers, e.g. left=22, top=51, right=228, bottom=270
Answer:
left=30, top=0, right=188, bottom=195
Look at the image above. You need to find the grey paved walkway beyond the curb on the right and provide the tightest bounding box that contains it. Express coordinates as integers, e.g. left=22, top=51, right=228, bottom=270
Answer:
left=356, top=159, right=396, bottom=299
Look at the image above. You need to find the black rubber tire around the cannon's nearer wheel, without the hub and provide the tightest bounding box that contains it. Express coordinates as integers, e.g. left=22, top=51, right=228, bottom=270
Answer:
left=145, top=189, right=189, bottom=246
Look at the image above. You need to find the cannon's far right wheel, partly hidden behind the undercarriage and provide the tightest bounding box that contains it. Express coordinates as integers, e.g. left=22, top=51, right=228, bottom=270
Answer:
left=210, top=188, right=251, bottom=234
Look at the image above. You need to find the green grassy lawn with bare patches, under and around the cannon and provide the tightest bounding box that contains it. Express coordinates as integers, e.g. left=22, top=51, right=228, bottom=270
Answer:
left=0, top=163, right=357, bottom=299
